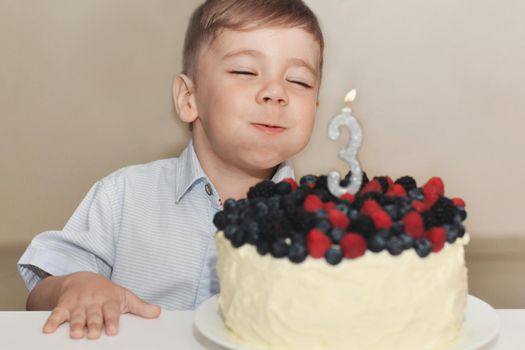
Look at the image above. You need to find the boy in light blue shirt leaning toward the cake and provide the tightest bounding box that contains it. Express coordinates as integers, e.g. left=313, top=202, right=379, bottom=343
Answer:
left=18, top=0, right=323, bottom=339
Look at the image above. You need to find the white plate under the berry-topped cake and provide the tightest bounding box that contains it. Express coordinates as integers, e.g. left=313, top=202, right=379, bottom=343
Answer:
left=195, top=295, right=500, bottom=350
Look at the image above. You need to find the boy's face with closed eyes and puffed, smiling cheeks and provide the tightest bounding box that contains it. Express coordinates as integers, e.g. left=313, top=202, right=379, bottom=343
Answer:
left=186, top=28, right=320, bottom=170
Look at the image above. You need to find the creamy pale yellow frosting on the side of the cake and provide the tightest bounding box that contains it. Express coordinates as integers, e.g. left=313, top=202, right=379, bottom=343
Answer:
left=216, top=232, right=469, bottom=350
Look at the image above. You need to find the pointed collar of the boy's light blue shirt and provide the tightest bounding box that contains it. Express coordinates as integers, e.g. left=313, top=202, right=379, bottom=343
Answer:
left=175, top=140, right=294, bottom=203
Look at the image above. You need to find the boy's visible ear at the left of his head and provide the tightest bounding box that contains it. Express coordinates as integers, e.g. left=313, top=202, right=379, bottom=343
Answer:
left=173, top=74, right=199, bottom=123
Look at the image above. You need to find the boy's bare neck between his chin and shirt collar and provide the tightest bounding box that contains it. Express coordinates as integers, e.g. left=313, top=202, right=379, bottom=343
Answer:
left=193, top=137, right=277, bottom=203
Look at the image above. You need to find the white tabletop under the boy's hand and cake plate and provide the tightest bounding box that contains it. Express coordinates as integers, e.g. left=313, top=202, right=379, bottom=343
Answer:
left=0, top=309, right=525, bottom=350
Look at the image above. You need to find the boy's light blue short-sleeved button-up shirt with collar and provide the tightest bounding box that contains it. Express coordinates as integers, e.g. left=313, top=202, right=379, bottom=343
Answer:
left=18, top=142, right=294, bottom=310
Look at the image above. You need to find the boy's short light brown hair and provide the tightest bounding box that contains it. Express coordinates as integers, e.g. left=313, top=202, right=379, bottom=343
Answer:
left=182, top=0, right=324, bottom=78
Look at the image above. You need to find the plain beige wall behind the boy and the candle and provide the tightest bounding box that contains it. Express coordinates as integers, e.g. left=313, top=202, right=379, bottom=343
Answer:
left=0, top=0, right=525, bottom=244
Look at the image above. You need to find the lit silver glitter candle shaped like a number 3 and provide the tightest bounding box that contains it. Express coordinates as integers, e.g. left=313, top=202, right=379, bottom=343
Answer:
left=328, top=89, right=363, bottom=197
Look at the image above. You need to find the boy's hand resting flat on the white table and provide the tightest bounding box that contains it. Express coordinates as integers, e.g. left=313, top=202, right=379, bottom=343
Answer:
left=43, top=272, right=160, bottom=339
